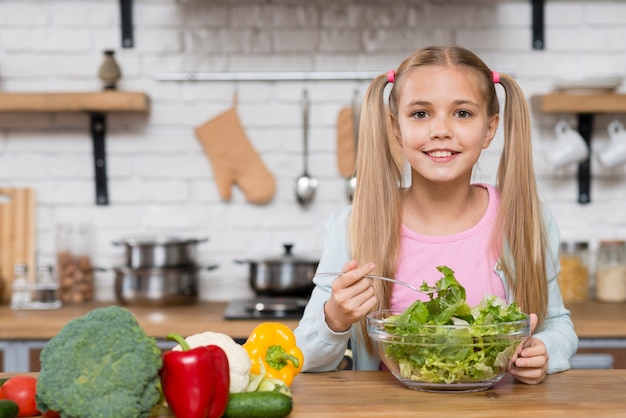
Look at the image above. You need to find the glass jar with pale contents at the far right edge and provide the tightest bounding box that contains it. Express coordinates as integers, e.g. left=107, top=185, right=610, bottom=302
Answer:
left=596, top=240, right=626, bottom=302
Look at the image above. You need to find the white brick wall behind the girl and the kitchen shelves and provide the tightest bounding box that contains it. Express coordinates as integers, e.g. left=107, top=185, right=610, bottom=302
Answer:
left=0, top=0, right=626, bottom=300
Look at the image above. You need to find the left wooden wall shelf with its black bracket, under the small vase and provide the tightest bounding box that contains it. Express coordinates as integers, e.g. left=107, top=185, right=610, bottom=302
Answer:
left=0, top=90, right=149, bottom=205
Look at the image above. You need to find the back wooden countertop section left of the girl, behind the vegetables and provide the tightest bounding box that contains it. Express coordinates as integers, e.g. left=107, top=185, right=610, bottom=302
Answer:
left=0, top=302, right=298, bottom=340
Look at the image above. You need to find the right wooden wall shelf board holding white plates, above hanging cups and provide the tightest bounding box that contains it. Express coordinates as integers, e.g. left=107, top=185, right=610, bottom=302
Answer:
left=533, top=93, right=626, bottom=113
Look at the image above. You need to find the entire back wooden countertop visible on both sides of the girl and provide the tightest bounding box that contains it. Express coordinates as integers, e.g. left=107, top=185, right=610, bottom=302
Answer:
left=0, top=301, right=626, bottom=340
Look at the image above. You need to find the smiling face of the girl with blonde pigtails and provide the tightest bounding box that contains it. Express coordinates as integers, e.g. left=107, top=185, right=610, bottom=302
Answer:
left=393, top=66, right=498, bottom=183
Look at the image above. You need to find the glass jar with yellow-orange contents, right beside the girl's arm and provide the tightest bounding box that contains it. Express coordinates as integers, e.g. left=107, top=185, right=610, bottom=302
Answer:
left=558, top=242, right=589, bottom=303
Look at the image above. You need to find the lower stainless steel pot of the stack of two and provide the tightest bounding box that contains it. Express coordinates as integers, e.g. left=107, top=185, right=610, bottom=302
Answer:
left=115, top=267, right=199, bottom=306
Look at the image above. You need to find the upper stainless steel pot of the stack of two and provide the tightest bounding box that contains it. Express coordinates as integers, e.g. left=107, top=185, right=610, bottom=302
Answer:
left=113, top=236, right=208, bottom=269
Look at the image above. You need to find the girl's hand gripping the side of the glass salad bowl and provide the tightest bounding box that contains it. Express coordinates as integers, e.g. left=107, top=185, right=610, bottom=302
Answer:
left=509, top=314, right=548, bottom=385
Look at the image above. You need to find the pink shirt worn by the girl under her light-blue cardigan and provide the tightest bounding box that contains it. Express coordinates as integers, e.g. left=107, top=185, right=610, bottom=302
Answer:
left=391, top=184, right=505, bottom=309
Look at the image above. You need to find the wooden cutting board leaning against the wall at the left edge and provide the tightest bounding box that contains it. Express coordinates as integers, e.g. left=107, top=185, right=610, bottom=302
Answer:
left=0, top=188, right=36, bottom=303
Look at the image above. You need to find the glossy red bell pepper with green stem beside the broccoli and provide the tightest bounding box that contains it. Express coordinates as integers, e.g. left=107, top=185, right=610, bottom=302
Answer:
left=161, top=334, right=230, bottom=418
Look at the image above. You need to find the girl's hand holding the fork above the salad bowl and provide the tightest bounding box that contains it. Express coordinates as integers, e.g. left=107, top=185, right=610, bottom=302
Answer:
left=324, top=260, right=377, bottom=332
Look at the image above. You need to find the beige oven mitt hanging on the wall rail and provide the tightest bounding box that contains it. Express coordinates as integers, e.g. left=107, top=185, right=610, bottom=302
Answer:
left=195, top=107, right=276, bottom=205
